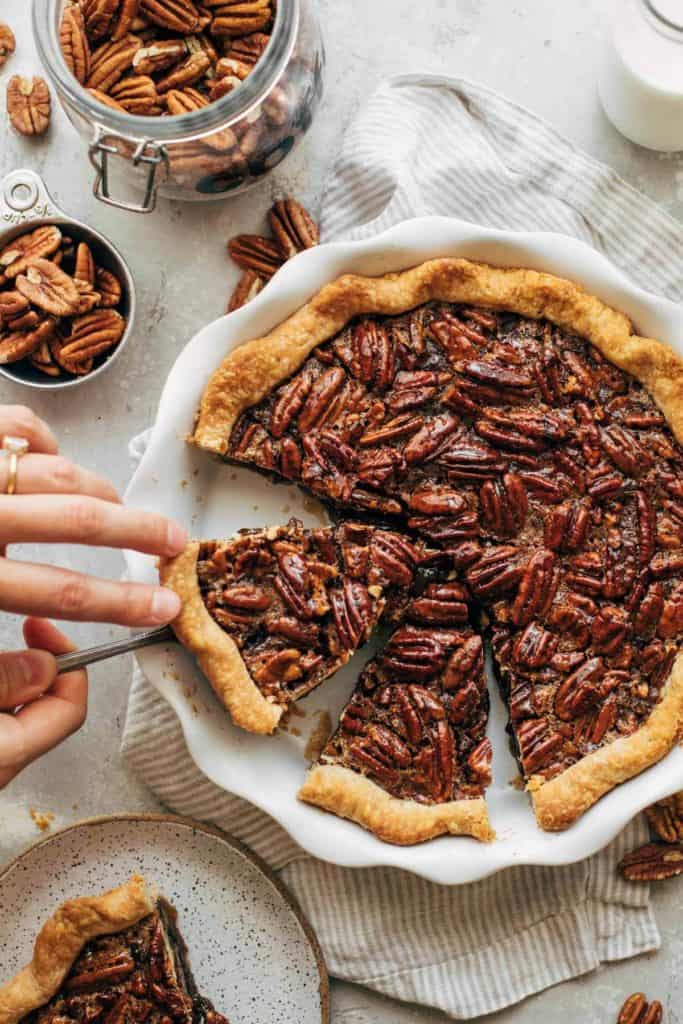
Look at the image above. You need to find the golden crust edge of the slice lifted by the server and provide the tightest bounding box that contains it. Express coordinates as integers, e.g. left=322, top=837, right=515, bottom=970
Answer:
left=159, top=541, right=283, bottom=733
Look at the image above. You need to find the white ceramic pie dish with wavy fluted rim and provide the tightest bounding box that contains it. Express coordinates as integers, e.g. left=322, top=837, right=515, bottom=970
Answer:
left=126, top=217, right=683, bottom=884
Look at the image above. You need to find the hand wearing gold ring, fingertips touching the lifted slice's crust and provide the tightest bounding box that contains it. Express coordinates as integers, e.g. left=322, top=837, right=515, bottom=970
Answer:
left=0, top=406, right=187, bottom=626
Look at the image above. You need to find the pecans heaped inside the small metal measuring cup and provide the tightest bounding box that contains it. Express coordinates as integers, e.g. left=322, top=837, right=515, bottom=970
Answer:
left=0, top=224, right=126, bottom=377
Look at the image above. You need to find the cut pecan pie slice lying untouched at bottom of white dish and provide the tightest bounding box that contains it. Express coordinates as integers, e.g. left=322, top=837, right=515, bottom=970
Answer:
left=299, top=583, right=494, bottom=844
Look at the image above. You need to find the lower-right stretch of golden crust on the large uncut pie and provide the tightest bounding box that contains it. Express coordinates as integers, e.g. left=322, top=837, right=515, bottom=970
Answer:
left=527, top=653, right=683, bottom=831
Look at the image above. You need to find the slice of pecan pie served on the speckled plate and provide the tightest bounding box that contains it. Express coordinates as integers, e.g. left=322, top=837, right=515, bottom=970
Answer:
left=0, top=876, right=227, bottom=1024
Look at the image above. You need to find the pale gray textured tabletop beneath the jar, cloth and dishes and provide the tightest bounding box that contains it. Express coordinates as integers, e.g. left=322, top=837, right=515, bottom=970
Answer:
left=0, top=0, right=683, bottom=1024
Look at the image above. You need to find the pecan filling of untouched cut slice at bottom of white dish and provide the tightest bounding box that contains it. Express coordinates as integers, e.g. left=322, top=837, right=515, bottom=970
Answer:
left=319, top=583, right=492, bottom=804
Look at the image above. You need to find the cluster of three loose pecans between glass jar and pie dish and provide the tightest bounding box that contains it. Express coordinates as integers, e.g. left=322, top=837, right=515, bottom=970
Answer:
left=227, top=199, right=319, bottom=313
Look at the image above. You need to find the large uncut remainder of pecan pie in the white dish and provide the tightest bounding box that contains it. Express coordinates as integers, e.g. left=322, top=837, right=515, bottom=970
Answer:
left=189, top=259, right=683, bottom=828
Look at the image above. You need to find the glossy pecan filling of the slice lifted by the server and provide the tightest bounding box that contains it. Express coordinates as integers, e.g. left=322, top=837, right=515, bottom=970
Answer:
left=197, top=519, right=425, bottom=705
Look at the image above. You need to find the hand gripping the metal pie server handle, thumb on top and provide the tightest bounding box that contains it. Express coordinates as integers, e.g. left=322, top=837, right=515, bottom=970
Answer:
left=0, top=618, right=88, bottom=790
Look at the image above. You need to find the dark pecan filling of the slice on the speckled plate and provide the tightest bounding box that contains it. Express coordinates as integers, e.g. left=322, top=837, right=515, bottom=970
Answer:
left=23, top=900, right=228, bottom=1024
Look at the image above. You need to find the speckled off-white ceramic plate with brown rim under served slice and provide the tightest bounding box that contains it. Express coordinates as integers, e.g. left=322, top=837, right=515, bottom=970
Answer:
left=0, top=815, right=330, bottom=1024
